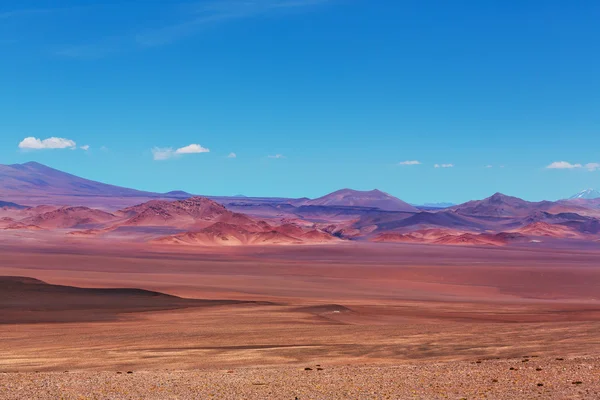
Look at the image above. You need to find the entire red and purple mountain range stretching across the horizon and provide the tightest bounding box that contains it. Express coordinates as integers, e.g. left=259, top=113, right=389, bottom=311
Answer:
left=0, top=163, right=600, bottom=246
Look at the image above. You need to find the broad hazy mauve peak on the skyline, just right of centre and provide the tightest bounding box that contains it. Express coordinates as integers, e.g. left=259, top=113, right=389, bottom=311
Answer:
left=303, top=189, right=419, bottom=212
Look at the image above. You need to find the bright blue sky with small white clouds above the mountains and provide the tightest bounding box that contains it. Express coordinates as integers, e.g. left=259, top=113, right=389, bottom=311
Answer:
left=0, top=0, right=600, bottom=203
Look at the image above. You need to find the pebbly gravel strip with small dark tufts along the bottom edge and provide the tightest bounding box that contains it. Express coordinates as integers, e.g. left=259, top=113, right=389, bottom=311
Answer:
left=0, top=355, right=600, bottom=400
